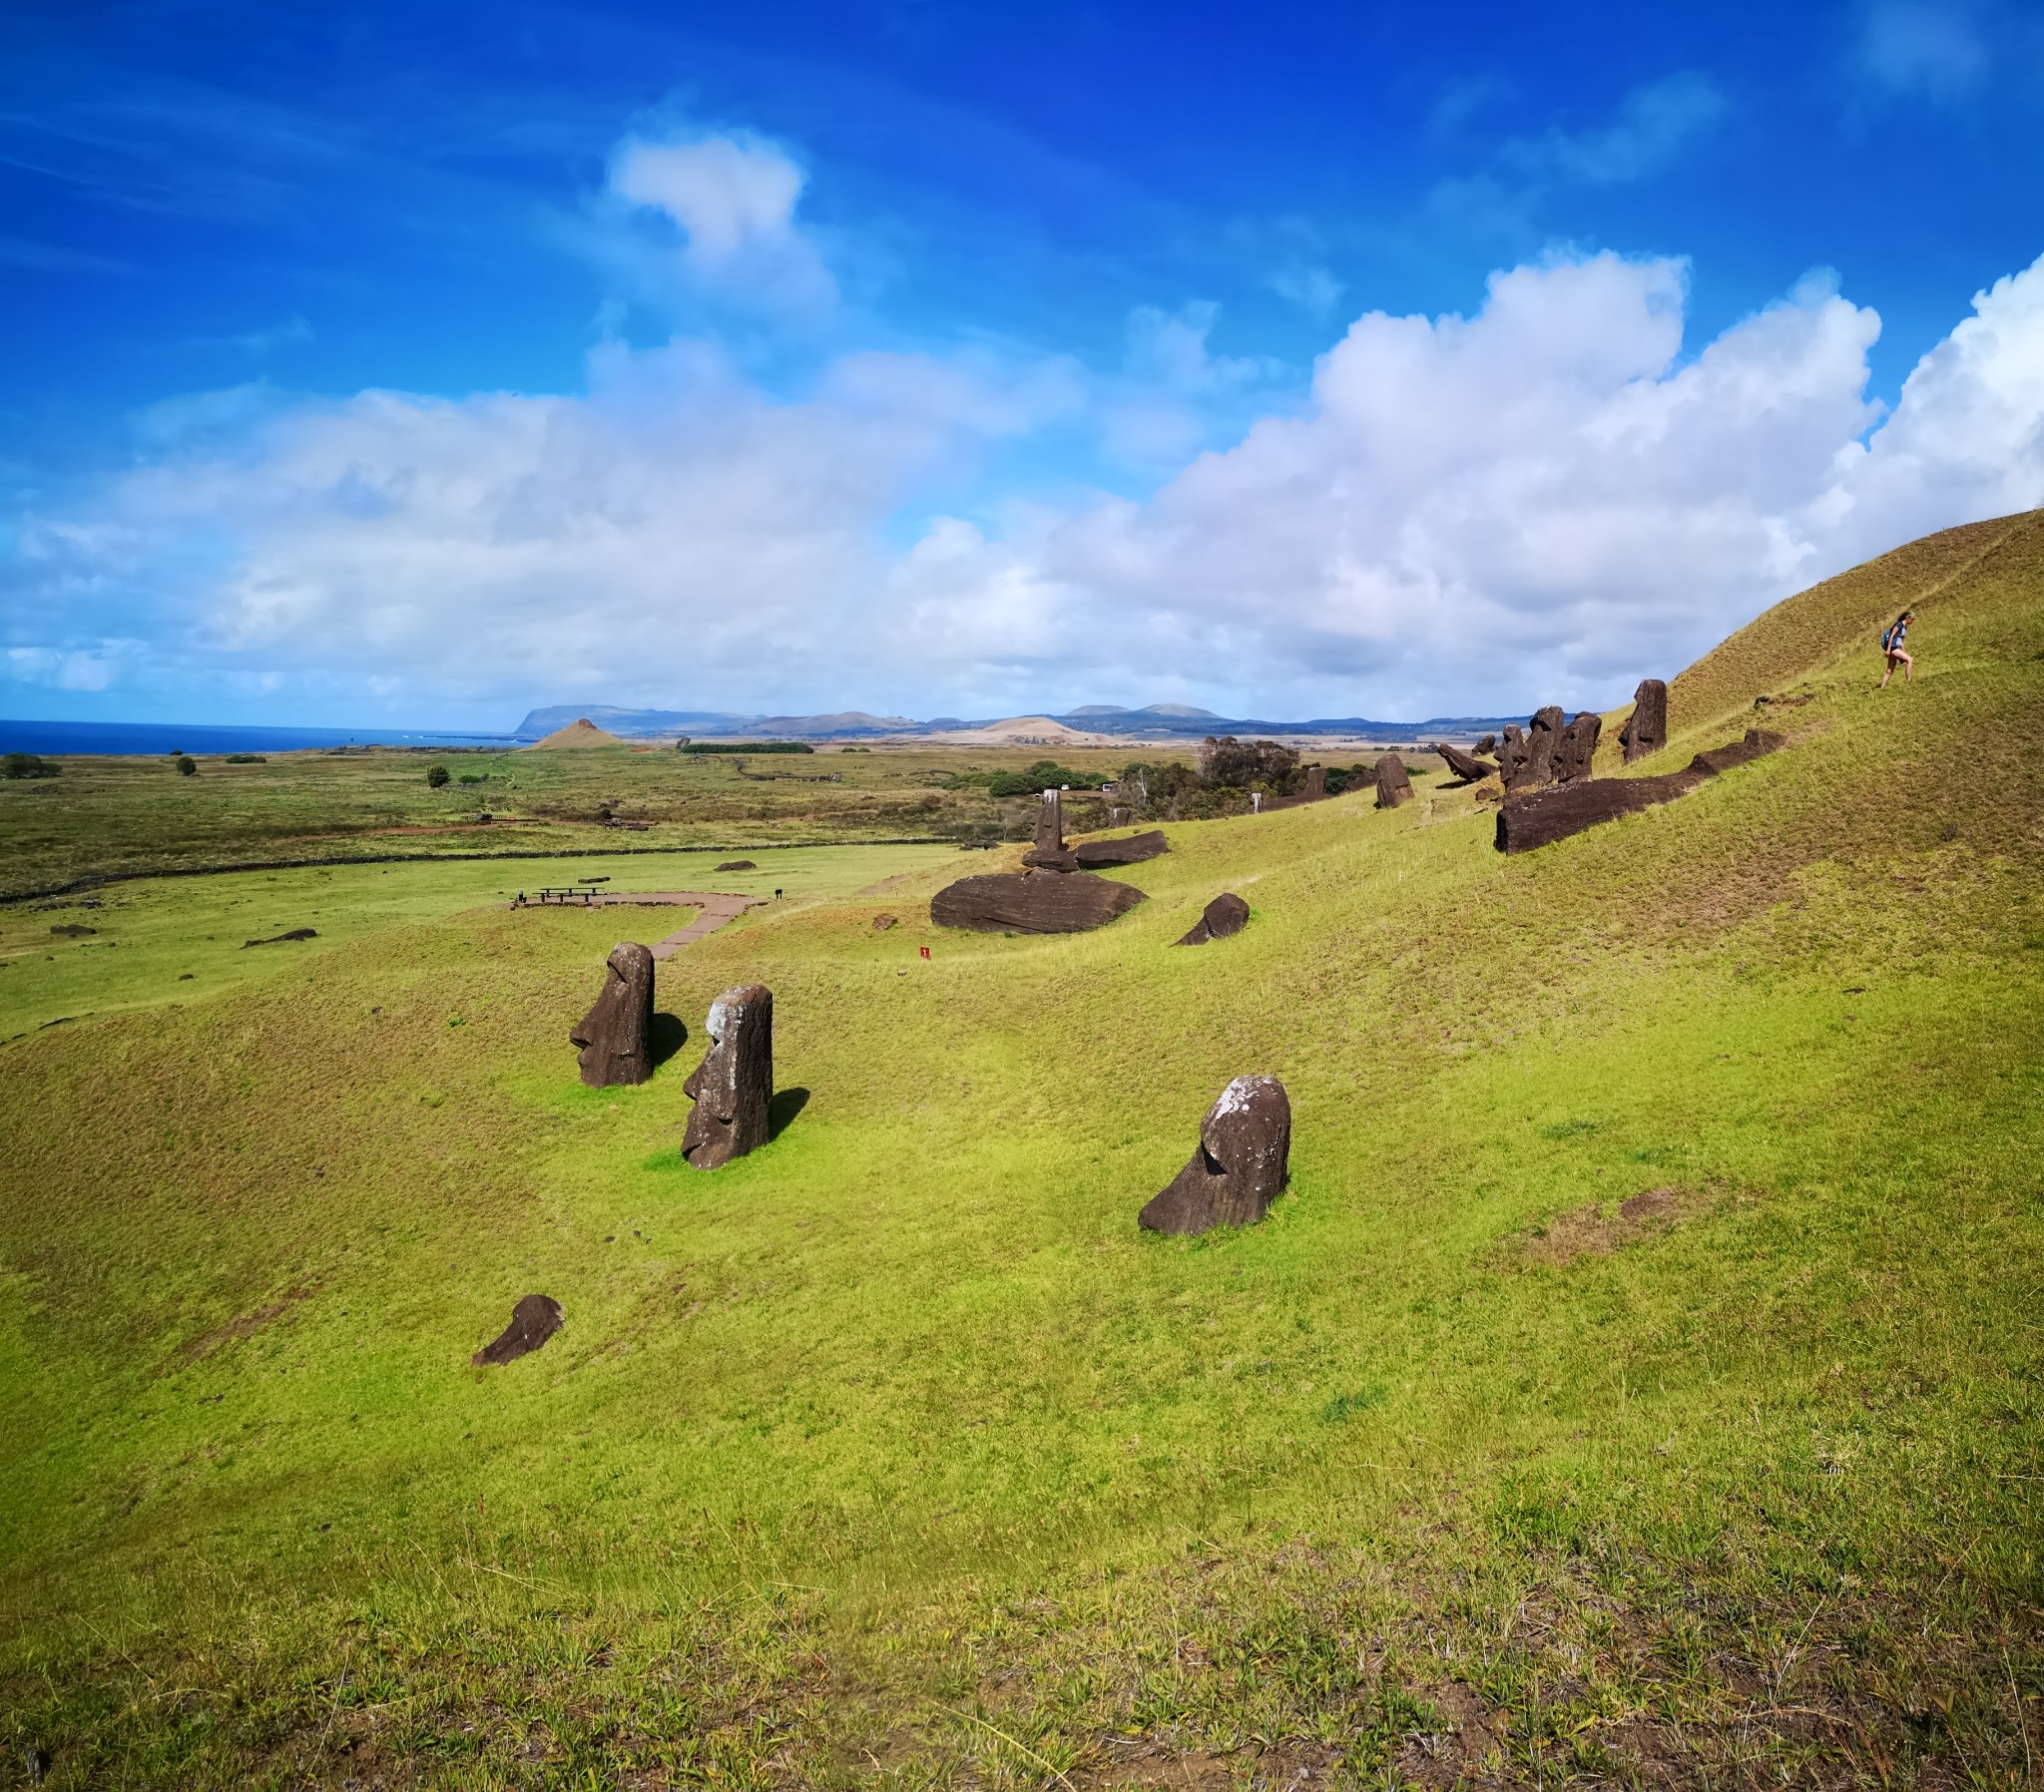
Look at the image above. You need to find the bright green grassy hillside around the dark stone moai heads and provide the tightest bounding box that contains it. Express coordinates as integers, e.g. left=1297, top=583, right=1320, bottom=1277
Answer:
left=0, top=515, right=2044, bottom=1788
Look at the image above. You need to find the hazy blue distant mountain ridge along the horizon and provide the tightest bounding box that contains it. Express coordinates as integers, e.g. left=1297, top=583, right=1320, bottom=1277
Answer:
left=513, top=702, right=1525, bottom=741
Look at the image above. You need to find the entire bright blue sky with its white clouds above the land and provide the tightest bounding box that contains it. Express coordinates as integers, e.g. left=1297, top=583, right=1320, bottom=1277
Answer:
left=0, top=0, right=2044, bottom=725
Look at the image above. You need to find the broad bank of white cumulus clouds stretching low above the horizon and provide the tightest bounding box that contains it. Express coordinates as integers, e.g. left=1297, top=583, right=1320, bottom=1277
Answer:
left=6, top=253, right=2044, bottom=719
